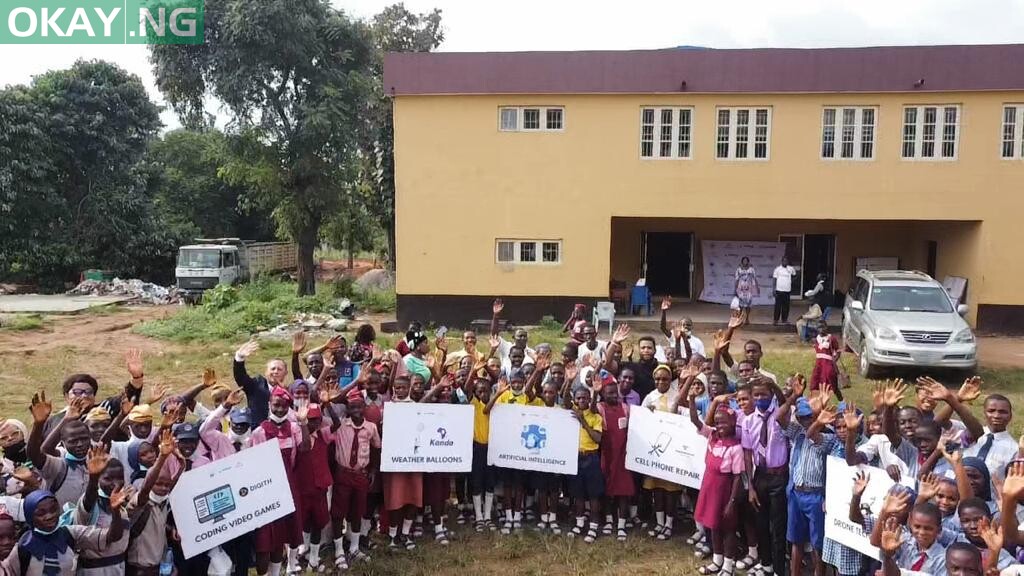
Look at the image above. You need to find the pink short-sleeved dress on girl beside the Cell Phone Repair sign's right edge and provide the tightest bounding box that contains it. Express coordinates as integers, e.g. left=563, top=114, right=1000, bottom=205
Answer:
left=693, top=425, right=743, bottom=530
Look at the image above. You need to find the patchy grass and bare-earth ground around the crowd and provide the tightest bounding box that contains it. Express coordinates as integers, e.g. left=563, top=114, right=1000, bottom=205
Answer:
left=0, top=287, right=1024, bottom=576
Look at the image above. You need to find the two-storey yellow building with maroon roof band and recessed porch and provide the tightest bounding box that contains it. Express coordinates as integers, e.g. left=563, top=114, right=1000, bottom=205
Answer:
left=384, top=45, right=1024, bottom=332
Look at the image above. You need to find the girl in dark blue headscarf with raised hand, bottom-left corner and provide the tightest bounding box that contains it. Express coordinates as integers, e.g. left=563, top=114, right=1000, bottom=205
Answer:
left=3, top=489, right=128, bottom=576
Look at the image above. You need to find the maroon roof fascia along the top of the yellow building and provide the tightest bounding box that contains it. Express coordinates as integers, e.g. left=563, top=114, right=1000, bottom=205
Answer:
left=384, top=44, right=1024, bottom=95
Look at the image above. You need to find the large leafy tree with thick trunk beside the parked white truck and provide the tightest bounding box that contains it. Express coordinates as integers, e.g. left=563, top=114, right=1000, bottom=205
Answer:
left=151, top=0, right=373, bottom=295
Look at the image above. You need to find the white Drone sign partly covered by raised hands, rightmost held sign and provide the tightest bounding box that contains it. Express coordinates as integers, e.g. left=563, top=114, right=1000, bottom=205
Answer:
left=825, top=456, right=895, bottom=560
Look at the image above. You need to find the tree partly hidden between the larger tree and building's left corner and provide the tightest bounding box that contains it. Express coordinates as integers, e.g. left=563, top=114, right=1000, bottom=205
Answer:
left=360, top=3, right=444, bottom=271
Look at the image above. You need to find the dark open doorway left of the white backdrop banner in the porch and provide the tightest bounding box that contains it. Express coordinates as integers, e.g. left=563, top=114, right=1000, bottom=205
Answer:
left=640, top=232, right=693, bottom=298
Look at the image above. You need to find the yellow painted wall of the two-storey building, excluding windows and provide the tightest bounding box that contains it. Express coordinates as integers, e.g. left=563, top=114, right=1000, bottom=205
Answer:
left=394, top=92, right=1024, bottom=330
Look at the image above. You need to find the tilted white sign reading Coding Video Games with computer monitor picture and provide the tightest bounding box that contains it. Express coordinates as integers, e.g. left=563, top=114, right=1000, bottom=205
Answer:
left=171, top=442, right=295, bottom=558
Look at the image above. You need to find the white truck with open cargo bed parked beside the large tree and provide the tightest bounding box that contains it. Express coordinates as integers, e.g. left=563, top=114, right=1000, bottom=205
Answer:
left=174, top=238, right=298, bottom=301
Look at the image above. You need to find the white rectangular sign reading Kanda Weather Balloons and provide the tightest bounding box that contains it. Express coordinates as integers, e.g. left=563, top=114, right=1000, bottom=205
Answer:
left=381, top=402, right=473, bottom=472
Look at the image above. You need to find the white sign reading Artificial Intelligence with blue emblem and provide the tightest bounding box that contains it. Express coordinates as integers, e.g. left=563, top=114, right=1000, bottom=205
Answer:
left=487, top=404, right=580, bottom=476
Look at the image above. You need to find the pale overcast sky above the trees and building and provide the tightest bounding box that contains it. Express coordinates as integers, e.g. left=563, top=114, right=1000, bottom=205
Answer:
left=0, top=0, right=1024, bottom=128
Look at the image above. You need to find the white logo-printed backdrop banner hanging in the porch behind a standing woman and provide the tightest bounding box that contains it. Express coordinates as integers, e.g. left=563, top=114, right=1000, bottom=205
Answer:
left=700, top=240, right=786, bottom=305
